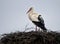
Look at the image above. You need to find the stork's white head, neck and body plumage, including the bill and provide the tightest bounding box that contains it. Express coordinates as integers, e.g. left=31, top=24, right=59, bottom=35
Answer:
left=27, top=7, right=39, bottom=22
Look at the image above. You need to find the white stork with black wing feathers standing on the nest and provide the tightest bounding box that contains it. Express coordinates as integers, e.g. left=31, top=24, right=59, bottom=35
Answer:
left=26, top=7, right=47, bottom=31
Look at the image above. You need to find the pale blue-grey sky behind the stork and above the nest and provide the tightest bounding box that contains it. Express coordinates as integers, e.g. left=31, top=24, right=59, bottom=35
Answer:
left=0, top=0, right=60, bottom=34
